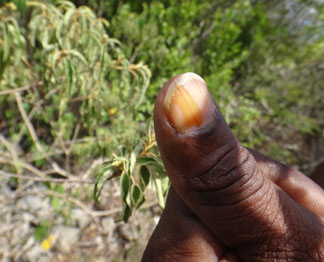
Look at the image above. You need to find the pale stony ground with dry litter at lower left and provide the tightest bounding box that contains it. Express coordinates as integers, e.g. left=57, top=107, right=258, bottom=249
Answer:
left=0, top=171, right=161, bottom=262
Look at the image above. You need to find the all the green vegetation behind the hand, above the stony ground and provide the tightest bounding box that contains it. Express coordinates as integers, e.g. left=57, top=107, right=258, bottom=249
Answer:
left=0, top=0, right=324, bottom=260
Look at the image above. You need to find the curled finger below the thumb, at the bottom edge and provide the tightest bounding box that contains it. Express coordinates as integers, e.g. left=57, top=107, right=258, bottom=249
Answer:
left=142, top=187, right=235, bottom=262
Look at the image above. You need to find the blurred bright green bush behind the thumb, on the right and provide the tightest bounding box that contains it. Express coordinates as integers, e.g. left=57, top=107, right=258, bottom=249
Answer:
left=97, top=0, right=324, bottom=165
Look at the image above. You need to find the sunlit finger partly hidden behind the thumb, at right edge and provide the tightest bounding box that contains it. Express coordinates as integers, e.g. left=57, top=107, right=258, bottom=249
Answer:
left=249, top=149, right=324, bottom=217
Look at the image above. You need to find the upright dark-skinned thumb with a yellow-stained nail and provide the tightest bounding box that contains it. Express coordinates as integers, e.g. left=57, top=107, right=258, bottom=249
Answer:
left=154, top=73, right=322, bottom=252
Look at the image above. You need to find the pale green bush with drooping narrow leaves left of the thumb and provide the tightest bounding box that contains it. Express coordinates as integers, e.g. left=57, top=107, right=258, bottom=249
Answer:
left=0, top=1, right=163, bottom=220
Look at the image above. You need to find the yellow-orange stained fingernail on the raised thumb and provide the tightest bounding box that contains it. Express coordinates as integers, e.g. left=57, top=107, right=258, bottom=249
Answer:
left=164, top=72, right=215, bottom=133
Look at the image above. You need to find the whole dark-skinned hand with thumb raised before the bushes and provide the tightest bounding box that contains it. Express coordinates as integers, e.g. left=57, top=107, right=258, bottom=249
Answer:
left=142, top=73, right=324, bottom=262
